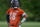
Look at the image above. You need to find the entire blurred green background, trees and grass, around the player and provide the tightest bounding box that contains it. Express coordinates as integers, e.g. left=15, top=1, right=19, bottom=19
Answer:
left=0, top=0, right=40, bottom=27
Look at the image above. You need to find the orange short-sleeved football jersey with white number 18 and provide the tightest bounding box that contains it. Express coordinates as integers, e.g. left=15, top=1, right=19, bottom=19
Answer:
left=7, top=8, right=24, bottom=25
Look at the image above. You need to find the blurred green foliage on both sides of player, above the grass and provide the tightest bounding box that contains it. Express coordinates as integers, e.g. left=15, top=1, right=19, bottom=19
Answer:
left=0, top=0, right=40, bottom=21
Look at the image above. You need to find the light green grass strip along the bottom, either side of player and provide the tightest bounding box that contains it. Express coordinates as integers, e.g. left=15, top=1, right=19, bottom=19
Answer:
left=0, top=22, right=40, bottom=27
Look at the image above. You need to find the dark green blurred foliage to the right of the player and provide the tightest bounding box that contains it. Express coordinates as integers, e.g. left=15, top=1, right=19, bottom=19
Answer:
left=20, top=0, right=40, bottom=21
